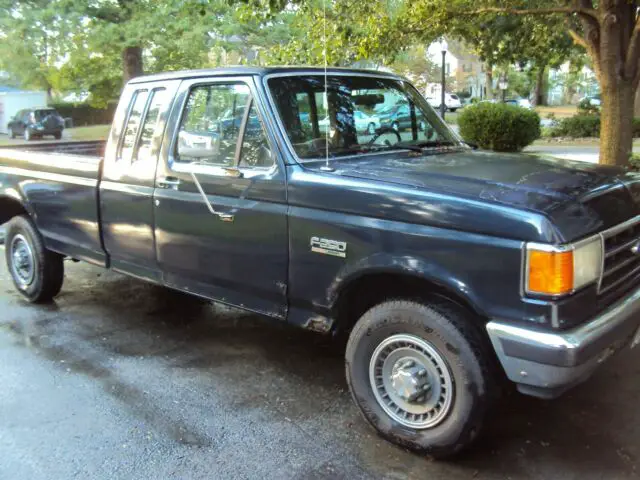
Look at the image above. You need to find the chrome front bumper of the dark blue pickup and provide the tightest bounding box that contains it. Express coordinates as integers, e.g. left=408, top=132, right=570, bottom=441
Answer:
left=487, top=288, right=640, bottom=398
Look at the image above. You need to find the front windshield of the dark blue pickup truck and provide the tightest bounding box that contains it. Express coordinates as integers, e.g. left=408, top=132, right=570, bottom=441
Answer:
left=268, top=75, right=460, bottom=160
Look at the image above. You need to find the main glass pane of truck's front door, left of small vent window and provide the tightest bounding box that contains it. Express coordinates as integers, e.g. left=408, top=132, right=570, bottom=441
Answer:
left=175, top=83, right=250, bottom=167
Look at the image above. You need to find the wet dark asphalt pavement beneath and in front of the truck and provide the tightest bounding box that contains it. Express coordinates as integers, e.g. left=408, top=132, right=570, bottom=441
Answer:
left=0, top=255, right=640, bottom=480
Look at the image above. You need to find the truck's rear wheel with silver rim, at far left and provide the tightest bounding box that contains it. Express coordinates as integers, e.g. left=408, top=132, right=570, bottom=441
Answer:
left=5, top=216, right=64, bottom=303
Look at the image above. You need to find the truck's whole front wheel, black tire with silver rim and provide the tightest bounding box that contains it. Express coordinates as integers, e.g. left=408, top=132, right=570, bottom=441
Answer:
left=346, top=300, right=495, bottom=458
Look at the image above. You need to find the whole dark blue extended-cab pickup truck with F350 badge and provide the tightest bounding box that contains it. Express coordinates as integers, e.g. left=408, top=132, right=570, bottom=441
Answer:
left=0, top=68, right=640, bottom=456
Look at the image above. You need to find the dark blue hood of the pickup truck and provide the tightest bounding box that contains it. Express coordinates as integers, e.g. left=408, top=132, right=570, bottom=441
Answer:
left=312, top=150, right=640, bottom=241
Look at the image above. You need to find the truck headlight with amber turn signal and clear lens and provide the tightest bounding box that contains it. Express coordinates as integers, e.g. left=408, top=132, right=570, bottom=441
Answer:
left=524, top=237, right=602, bottom=296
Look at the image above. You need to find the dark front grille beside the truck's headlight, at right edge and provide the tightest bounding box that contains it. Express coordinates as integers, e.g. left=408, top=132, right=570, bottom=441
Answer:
left=598, top=218, right=640, bottom=294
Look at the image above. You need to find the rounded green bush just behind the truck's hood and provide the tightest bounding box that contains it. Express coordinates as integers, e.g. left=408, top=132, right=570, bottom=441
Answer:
left=458, top=102, right=540, bottom=152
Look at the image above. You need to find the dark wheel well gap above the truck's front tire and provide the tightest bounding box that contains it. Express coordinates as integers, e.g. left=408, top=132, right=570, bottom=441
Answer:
left=332, top=273, right=487, bottom=335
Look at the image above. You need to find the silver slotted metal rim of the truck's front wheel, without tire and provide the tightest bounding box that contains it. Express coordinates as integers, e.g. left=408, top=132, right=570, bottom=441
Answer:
left=369, top=334, right=454, bottom=429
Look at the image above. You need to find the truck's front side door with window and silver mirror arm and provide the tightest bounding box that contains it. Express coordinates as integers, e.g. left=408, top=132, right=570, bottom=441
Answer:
left=154, top=77, right=288, bottom=319
